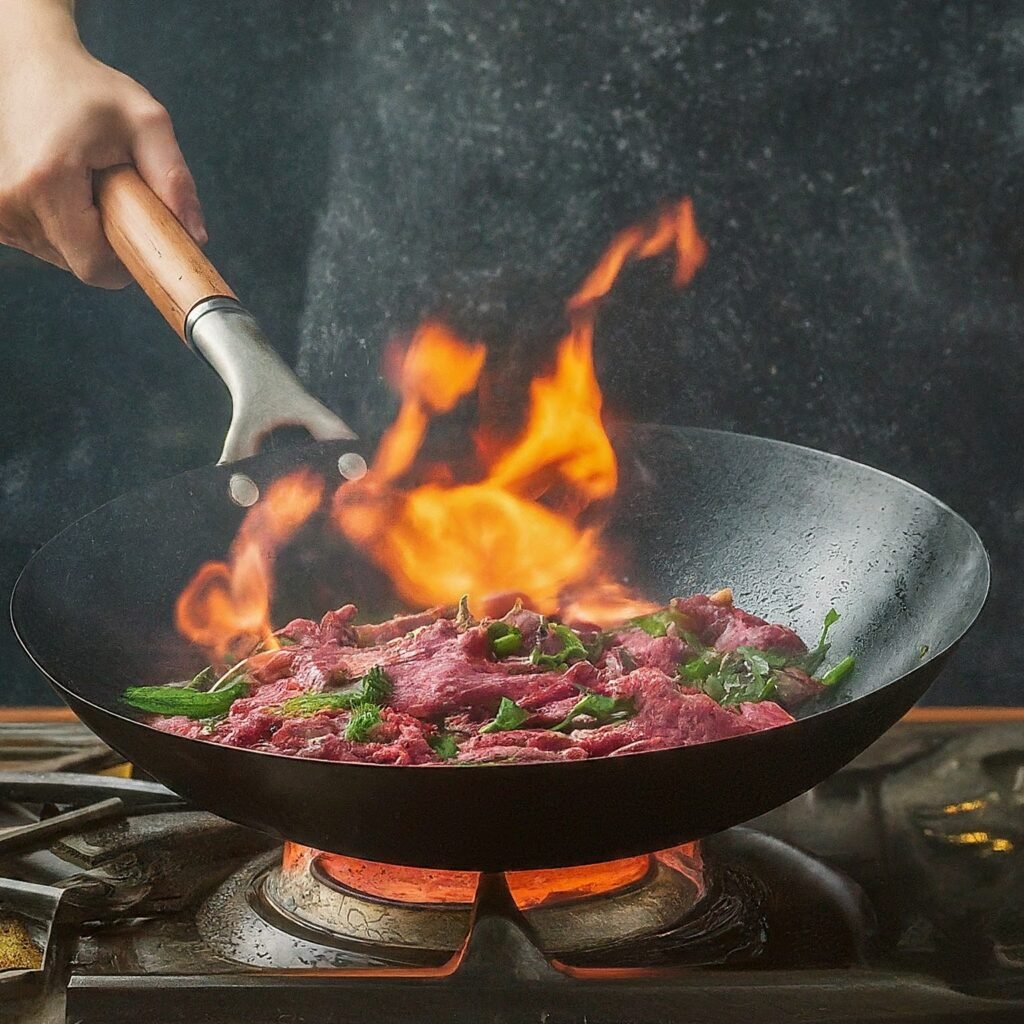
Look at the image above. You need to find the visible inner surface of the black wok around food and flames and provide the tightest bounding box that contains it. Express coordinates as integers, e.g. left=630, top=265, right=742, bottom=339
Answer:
left=13, top=426, right=988, bottom=729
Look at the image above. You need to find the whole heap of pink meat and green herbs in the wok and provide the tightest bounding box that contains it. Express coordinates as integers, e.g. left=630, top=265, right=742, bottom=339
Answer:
left=125, top=591, right=853, bottom=765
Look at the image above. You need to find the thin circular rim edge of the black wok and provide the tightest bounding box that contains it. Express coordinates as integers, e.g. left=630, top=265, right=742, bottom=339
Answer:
left=8, top=423, right=992, bottom=775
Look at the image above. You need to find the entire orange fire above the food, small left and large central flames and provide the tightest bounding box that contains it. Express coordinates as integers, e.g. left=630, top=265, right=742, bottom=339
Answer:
left=175, top=199, right=707, bottom=662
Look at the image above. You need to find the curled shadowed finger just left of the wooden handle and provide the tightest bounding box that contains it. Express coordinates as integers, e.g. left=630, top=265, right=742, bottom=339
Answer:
left=37, top=168, right=131, bottom=288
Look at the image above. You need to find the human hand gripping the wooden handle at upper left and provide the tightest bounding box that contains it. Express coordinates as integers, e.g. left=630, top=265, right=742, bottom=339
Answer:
left=0, top=0, right=207, bottom=288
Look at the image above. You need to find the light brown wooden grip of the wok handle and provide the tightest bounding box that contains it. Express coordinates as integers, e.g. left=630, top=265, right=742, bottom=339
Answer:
left=93, top=164, right=236, bottom=341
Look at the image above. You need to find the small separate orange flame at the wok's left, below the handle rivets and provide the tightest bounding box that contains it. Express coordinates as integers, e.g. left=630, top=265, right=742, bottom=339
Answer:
left=174, top=469, right=324, bottom=663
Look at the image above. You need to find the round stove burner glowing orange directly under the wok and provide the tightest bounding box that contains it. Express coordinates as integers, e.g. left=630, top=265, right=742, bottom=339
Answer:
left=198, top=846, right=706, bottom=967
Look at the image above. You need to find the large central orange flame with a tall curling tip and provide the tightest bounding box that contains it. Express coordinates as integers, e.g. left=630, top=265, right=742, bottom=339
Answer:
left=334, top=199, right=707, bottom=625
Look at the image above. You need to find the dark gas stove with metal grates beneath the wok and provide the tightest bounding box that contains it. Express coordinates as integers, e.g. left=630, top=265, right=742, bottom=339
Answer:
left=0, top=717, right=1024, bottom=1024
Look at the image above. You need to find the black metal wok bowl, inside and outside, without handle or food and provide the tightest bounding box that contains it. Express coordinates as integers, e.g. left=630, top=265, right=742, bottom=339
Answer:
left=12, top=426, right=989, bottom=870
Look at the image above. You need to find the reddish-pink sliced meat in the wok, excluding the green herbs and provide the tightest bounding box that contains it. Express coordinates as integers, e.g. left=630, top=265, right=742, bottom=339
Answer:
left=148, top=594, right=822, bottom=765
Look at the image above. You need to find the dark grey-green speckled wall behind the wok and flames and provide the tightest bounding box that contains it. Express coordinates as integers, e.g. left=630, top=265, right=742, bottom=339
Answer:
left=0, top=0, right=1024, bottom=703
